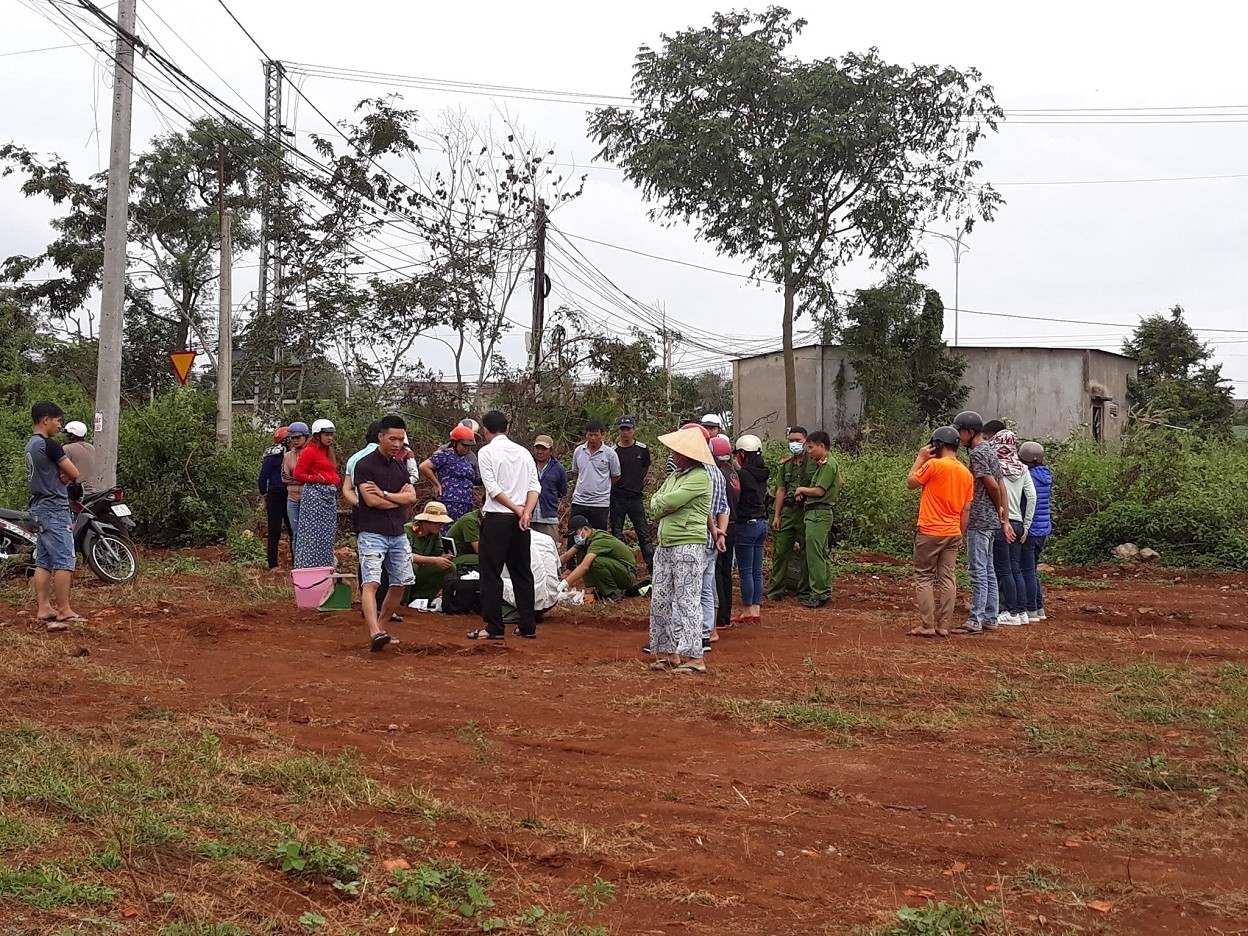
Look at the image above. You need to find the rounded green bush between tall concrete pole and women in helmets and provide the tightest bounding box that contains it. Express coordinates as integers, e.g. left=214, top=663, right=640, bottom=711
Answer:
left=117, top=389, right=266, bottom=547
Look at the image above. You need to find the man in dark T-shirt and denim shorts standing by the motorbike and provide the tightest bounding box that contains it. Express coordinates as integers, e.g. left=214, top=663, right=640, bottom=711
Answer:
left=26, top=401, right=85, bottom=633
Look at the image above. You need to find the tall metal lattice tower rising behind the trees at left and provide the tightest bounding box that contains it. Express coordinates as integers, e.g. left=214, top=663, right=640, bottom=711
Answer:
left=256, top=60, right=286, bottom=408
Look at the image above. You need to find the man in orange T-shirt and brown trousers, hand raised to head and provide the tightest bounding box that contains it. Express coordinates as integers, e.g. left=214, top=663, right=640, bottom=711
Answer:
left=906, top=426, right=975, bottom=636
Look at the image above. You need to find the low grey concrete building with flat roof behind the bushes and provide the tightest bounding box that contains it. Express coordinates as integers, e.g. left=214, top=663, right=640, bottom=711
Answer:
left=733, top=344, right=1136, bottom=439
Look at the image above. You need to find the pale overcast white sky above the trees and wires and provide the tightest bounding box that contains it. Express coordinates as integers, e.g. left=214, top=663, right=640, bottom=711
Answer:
left=0, top=0, right=1248, bottom=397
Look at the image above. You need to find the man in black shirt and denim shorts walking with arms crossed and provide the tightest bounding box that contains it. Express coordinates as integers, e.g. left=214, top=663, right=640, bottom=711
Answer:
left=351, top=416, right=416, bottom=653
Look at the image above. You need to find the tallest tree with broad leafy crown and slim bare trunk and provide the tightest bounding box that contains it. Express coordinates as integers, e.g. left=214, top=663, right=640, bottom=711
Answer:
left=589, top=6, right=1002, bottom=423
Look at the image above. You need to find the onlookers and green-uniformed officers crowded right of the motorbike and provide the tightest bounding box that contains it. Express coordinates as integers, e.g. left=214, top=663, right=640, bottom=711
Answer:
left=260, top=411, right=1052, bottom=658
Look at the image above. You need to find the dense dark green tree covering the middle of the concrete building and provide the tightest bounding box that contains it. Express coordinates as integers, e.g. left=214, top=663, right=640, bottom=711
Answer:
left=841, top=277, right=971, bottom=442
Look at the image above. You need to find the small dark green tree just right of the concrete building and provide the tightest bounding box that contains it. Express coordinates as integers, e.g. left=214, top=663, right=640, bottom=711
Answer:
left=1122, top=306, right=1234, bottom=433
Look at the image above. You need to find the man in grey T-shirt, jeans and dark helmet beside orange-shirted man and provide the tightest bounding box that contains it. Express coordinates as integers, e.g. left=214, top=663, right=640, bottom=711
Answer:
left=950, top=409, right=1013, bottom=636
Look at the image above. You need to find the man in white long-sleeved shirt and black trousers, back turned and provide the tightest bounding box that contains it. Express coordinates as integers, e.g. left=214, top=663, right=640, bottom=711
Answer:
left=468, top=409, right=542, bottom=640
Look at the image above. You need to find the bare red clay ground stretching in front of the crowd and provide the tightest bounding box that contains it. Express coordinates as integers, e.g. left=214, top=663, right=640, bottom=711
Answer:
left=6, top=561, right=1248, bottom=935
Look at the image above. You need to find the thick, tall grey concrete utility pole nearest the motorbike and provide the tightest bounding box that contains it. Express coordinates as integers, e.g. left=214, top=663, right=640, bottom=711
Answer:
left=95, top=0, right=137, bottom=489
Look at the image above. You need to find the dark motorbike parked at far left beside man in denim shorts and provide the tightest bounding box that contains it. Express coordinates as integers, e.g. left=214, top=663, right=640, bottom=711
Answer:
left=0, top=488, right=139, bottom=584
